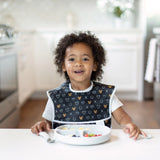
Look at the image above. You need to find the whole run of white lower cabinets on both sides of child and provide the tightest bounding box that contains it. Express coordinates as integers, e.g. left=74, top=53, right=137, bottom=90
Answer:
left=19, top=29, right=143, bottom=102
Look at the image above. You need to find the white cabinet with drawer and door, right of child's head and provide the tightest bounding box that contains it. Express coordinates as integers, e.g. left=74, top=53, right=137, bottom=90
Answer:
left=98, top=31, right=143, bottom=100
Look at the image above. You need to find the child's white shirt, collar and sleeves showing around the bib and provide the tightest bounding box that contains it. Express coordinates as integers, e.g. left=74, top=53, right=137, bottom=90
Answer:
left=42, top=82, right=123, bottom=122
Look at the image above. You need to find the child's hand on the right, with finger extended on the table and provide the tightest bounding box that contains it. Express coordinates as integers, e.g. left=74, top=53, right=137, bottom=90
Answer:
left=123, top=123, right=147, bottom=140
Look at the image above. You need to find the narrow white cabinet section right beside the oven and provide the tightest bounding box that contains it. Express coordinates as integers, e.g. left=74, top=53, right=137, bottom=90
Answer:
left=17, top=32, right=35, bottom=106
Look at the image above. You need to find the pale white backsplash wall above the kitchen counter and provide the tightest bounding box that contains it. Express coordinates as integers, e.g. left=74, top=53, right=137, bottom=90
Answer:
left=0, top=0, right=136, bottom=30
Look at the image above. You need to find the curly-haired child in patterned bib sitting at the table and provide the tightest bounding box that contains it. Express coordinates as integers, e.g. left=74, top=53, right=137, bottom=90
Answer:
left=31, top=32, right=146, bottom=139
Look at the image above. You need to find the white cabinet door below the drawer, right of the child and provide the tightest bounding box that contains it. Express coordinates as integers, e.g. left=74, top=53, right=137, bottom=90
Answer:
left=102, top=48, right=137, bottom=91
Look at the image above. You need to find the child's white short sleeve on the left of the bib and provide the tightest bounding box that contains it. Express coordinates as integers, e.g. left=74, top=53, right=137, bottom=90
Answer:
left=42, top=98, right=54, bottom=122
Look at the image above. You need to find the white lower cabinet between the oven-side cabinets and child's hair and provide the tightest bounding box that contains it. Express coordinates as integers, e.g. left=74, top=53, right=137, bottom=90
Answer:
left=35, top=31, right=65, bottom=91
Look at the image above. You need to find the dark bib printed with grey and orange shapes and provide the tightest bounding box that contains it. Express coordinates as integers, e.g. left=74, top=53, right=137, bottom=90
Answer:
left=49, top=82, right=114, bottom=127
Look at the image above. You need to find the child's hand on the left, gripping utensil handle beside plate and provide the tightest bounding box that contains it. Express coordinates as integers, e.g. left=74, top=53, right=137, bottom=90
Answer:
left=31, top=121, right=51, bottom=135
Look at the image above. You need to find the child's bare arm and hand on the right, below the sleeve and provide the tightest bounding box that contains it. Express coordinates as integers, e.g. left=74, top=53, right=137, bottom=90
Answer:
left=112, top=107, right=147, bottom=140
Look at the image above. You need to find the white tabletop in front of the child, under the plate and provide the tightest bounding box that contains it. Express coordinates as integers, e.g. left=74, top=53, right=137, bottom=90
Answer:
left=0, top=129, right=160, bottom=160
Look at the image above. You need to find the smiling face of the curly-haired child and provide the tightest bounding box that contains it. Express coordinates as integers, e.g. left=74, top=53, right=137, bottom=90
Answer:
left=62, top=43, right=97, bottom=83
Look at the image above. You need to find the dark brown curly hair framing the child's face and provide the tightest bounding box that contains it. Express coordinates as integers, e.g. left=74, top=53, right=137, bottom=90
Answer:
left=54, top=31, right=106, bottom=80
